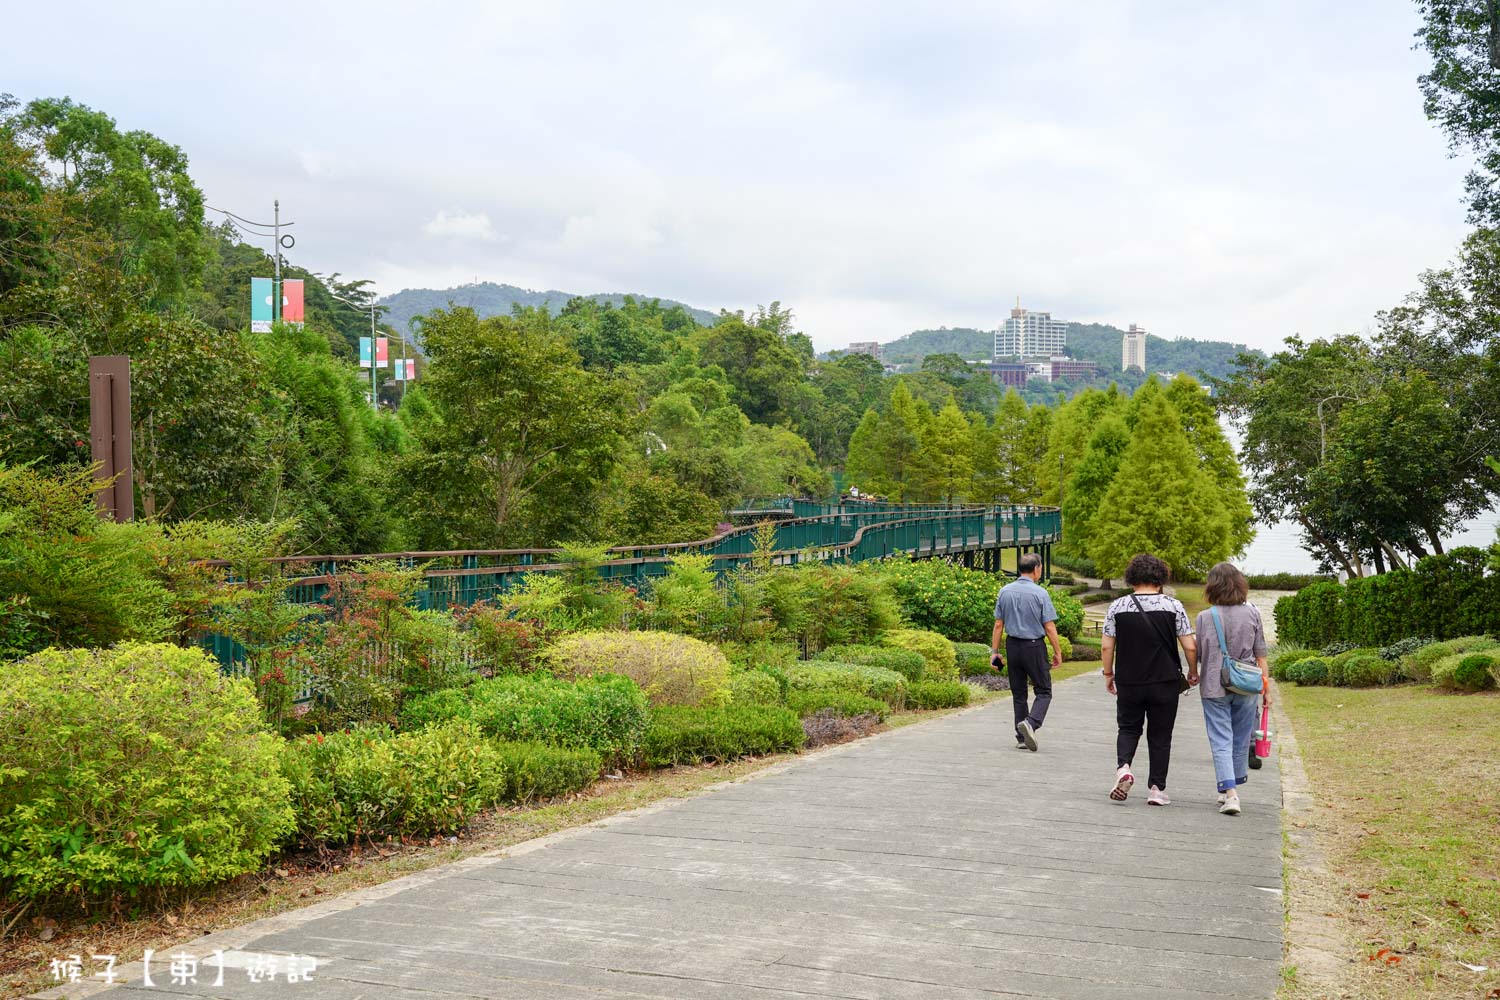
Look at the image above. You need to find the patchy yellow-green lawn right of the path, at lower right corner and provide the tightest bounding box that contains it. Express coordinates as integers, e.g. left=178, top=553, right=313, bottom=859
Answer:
left=1278, top=685, right=1500, bottom=1000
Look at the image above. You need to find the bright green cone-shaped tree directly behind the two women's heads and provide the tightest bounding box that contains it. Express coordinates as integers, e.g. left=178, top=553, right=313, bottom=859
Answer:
left=1088, top=394, right=1230, bottom=579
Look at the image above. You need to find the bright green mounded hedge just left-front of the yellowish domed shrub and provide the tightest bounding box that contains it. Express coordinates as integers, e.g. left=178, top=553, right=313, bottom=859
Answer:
left=401, top=673, right=648, bottom=765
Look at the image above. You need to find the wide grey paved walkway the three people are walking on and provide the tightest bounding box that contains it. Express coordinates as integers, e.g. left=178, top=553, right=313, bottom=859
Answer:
left=74, top=675, right=1281, bottom=1000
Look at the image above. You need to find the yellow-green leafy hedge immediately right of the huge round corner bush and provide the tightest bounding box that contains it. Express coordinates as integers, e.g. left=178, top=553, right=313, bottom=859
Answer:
left=281, top=721, right=506, bottom=847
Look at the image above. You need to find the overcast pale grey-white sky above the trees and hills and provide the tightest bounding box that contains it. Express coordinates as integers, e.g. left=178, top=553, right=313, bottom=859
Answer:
left=0, top=0, right=1466, bottom=348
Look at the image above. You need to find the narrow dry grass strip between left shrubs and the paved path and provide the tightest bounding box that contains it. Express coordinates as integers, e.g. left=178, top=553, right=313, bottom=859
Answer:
left=0, top=695, right=996, bottom=1000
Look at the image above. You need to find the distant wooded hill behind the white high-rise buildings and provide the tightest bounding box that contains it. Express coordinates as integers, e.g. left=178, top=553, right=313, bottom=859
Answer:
left=881, top=322, right=1247, bottom=376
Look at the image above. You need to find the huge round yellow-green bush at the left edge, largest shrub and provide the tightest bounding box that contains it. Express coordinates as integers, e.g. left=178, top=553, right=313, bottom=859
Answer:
left=0, top=645, right=294, bottom=903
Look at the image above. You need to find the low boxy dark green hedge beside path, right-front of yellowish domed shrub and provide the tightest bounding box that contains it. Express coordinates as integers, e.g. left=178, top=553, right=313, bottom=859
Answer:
left=642, top=705, right=807, bottom=768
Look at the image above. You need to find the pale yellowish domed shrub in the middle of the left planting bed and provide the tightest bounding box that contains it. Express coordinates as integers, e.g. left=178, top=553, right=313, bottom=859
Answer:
left=543, top=631, right=729, bottom=708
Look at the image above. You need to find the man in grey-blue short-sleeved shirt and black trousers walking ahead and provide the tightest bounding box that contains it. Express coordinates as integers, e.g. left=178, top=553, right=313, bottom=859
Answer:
left=990, top=552, right=1062, bottom=751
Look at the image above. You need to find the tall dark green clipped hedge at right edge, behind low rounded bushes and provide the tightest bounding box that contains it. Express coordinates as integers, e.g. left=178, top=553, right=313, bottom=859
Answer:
left=1277, top=547, right=1500, bottom=646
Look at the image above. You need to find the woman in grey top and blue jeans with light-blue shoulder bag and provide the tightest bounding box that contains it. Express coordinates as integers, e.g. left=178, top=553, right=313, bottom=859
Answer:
left=1197, top=562, right=1271, bottom=816
